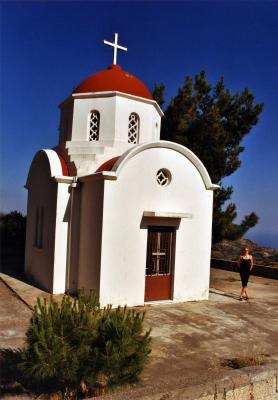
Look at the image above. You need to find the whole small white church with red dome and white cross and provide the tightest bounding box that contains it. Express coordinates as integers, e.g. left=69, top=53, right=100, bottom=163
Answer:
left=25, top=34, right=218, bottom=306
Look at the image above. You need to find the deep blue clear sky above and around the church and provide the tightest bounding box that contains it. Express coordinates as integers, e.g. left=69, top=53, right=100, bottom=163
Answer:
left=0, top=1, right=278, bottom=242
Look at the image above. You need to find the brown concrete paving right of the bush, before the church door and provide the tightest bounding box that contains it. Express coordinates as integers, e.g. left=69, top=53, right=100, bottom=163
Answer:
left=136, top=269, right=278, bottom=399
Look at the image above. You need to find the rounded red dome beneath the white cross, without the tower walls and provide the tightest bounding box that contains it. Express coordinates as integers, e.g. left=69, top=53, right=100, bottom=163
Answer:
left=73, top=64, right=153, bottom=100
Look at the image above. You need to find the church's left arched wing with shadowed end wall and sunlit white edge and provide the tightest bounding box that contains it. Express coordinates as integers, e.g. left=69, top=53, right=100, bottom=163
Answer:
left=25, top=150, right=69, bottom=293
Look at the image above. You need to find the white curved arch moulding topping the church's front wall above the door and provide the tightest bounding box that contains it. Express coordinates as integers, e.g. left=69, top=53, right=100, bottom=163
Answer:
left=111, top=140, right=219, bottom=190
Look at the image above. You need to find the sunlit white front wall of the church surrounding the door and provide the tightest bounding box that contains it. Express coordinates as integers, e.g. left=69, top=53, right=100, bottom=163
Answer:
left=79, top=148, right=213, bottom=306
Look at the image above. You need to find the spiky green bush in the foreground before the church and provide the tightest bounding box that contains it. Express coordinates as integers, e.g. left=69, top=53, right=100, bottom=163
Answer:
left=19, top=290, right=151, bottom=398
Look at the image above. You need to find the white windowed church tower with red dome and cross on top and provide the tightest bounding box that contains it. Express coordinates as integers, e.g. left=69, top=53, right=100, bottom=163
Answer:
left=55, top=33, right=163, bottom=176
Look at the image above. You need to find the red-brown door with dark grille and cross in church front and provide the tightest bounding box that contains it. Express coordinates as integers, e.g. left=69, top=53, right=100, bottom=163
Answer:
left=145, top=227, right=175, bottom=301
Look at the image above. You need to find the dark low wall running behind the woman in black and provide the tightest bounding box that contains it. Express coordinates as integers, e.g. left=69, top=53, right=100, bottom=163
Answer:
left=210, top=258, right=278, bottom=279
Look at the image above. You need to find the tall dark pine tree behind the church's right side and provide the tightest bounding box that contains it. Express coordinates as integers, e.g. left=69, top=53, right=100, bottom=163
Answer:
left=153, top=71, right=263, bottom=242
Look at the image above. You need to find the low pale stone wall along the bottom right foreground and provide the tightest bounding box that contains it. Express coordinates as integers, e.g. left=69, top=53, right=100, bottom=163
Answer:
left=94, top=362, right=278, bottom=400
